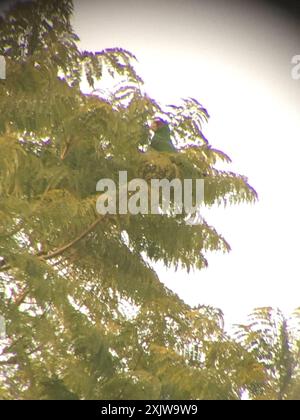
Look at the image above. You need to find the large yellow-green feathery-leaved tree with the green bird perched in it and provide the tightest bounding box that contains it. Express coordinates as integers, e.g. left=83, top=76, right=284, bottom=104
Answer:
left=0, top=0, right=263, bottom=399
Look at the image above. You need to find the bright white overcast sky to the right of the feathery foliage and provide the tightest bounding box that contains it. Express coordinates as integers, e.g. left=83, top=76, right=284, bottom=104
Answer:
left=73, top=0, right=300, bottom=323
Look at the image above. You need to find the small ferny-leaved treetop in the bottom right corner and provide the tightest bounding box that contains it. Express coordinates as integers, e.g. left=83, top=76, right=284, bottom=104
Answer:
left=237, top=307, right=300, bottom=401
